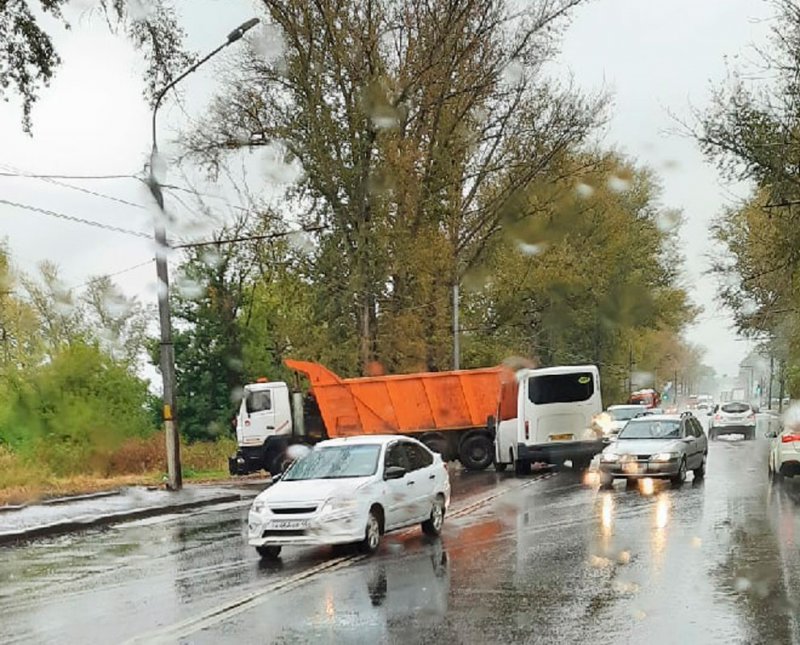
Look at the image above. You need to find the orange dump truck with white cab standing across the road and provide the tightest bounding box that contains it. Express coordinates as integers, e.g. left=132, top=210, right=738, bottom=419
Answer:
left=229, top=360, right=516, bottom=474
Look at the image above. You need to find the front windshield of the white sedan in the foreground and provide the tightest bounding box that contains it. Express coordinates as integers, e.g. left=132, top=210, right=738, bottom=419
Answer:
left=282, top=444, right=381, bottom=481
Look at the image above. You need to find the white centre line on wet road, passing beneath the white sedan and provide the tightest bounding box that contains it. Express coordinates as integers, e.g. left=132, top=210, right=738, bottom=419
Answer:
left=125, top=471, right=557, bottom=645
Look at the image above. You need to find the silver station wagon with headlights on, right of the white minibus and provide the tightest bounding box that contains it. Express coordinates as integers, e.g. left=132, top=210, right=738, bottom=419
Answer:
left=599, top=412, right=708, bottom=487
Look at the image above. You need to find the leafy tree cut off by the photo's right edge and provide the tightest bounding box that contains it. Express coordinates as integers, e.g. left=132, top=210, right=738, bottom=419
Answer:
left=695, top=0, right=800, bottom=394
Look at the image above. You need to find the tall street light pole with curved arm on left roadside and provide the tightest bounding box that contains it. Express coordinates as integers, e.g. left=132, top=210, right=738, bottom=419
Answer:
left=147, top=18, right=259, bottom=490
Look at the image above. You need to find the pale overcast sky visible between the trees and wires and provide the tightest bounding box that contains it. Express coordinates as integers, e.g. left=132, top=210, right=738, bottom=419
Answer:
left=0, top=0, right=770, bottom=374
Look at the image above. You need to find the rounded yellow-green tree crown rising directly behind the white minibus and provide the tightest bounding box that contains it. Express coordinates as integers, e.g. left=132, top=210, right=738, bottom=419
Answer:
left=456, top=155, right=694, bottom=400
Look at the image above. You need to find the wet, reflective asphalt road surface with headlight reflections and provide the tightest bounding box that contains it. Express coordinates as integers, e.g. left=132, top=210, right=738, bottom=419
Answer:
left=0, top=426, right=800, bottom=644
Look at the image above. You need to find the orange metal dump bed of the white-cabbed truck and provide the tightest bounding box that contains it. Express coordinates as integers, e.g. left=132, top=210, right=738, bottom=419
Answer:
left=284, top=360, right=516, bottom=438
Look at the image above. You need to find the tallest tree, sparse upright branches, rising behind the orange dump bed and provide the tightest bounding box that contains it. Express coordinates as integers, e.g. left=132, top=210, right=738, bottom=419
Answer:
left=188, top=0, right=602, bottom=370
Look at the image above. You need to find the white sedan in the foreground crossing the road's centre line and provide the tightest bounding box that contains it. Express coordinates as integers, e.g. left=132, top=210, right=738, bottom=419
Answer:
left=248, top=435, right=450, bottom=558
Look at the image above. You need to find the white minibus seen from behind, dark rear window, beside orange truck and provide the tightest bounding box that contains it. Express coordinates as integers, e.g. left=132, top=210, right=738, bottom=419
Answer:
left=495, top=365, right=604, bottom=474
